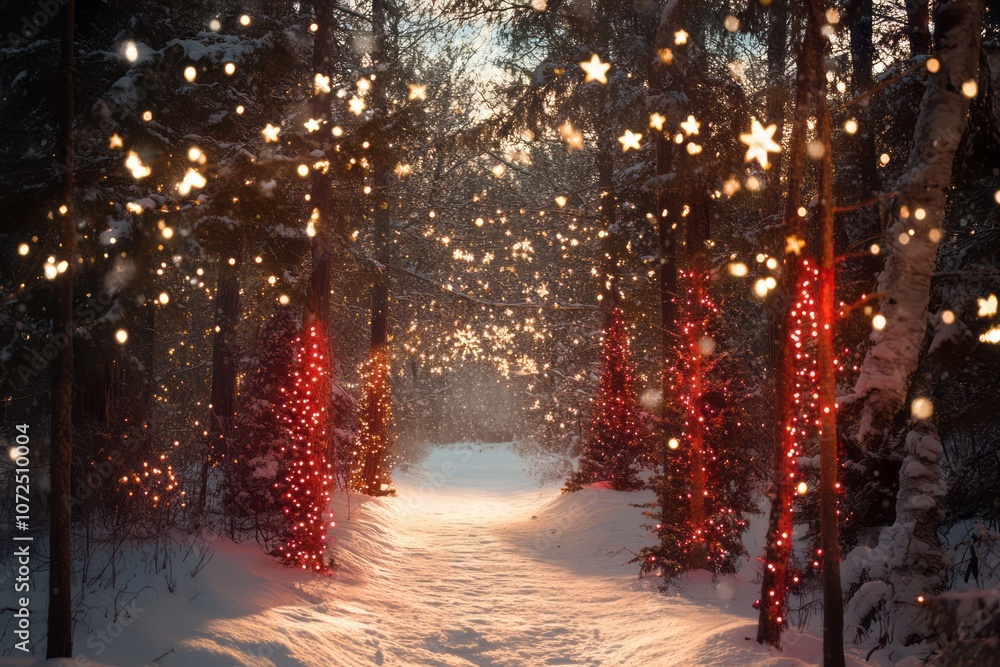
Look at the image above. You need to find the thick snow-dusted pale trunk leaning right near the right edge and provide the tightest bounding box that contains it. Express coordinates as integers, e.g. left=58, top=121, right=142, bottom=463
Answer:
left=849, top=0, right=983, bottom=450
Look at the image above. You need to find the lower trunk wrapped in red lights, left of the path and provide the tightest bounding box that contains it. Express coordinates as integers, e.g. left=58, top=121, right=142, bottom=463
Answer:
left=281, top=322, right=333, bottom=574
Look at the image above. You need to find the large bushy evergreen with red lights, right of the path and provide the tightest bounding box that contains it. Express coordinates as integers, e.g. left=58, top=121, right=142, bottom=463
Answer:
left=636, top=270, right=754, bottom=588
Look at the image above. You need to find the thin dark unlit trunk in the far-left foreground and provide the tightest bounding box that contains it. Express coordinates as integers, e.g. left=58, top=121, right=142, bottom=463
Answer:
left=46, top=0, right=76, bottom=658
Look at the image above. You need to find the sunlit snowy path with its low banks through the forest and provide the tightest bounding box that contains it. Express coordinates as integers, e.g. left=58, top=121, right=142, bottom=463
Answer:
left=0, top=445, right=864, bottom=667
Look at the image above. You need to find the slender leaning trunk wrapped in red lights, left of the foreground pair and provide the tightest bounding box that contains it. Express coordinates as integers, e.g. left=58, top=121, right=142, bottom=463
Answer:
left=757, top=0, right=820, bottom=648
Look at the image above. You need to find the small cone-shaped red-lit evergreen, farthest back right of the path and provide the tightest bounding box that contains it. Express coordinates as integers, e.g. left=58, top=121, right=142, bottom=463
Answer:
left=565, top=308, right=648, bottom=491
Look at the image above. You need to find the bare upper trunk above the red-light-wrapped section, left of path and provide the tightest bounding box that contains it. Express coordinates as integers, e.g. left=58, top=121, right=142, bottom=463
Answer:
left=306, top=0, right=335, bottom=332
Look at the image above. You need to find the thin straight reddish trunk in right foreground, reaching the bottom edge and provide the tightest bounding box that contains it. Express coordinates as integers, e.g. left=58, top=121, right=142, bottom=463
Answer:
left=811, top=72, right=844, bottom=667
